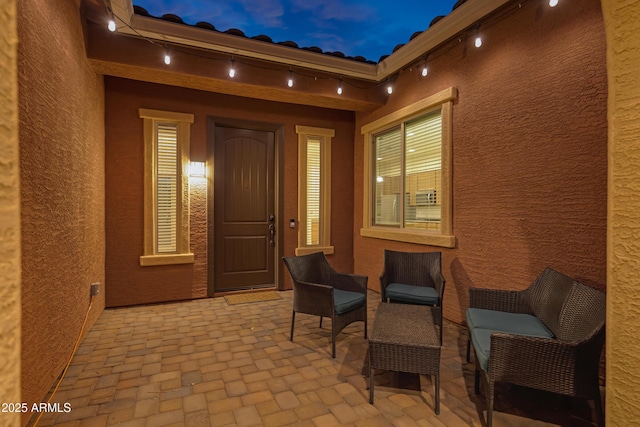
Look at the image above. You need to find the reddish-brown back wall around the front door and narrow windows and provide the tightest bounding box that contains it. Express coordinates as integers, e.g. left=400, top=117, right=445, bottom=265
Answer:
left=106, top=78, right=354, bottom=306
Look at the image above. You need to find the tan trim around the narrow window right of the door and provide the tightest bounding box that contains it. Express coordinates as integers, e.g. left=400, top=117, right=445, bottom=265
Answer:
left=295, top=126, right=335, bottom=255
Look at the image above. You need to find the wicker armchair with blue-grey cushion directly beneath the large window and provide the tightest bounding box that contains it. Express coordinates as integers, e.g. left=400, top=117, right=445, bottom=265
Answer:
left=380, top=250, right=445, bottom=343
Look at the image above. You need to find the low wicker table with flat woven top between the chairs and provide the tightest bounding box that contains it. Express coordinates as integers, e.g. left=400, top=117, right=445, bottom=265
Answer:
left=369, top=303, right=440, bottom=414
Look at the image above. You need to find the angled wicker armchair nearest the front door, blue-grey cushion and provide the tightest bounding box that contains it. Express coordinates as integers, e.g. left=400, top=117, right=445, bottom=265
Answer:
left=283, top=252, right=368, bottom=358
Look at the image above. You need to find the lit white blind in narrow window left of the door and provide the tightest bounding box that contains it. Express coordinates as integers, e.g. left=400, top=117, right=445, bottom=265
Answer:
left=156, top=123, right=179, bottom=254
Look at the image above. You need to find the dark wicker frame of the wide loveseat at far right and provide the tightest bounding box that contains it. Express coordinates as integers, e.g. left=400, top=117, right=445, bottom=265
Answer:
left=467, top=268, right=606, bottom=427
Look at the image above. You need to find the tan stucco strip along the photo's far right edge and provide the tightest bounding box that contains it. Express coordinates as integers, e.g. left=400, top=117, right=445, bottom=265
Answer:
left=602, top=0, right=640, bottom=427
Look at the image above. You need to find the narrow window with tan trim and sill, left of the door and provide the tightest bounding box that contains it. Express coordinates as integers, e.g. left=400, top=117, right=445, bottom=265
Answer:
left=139, top=108, right=194, bottom=266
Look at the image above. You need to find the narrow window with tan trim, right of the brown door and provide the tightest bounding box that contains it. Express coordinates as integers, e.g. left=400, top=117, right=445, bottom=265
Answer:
left=295, top=126, right=335, bottom=255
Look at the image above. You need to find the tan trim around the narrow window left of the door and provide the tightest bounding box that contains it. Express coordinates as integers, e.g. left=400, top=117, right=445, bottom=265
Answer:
left=138, top=108, right=194, bottom=266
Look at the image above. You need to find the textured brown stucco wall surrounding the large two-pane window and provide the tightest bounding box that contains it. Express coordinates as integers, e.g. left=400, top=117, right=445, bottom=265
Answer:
left=354, top=0, right=607, bottom=322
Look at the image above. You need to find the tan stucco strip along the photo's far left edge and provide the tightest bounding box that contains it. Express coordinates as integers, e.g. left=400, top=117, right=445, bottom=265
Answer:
left=0, top=0, right=21, bottom=426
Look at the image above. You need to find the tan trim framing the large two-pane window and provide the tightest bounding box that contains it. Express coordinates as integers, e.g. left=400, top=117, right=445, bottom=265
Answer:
left=360, top=87, right=458, bottom=248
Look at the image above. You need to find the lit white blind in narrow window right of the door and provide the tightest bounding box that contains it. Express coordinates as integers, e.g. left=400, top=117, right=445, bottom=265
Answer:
left=306, top=136, right=322, bottom=246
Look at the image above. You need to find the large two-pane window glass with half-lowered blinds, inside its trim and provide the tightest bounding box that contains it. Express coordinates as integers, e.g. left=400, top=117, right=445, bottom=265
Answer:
left=373, top=109, right=442, bottom=230
